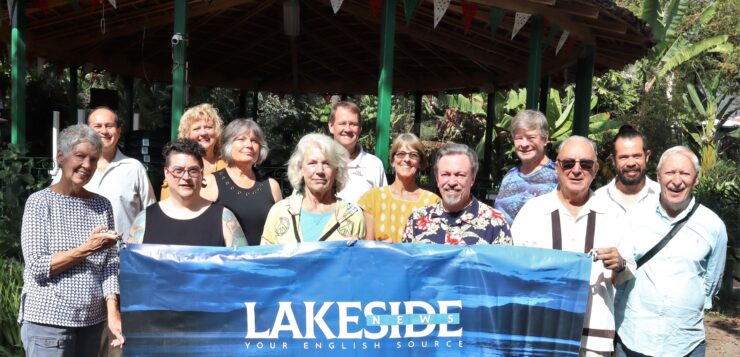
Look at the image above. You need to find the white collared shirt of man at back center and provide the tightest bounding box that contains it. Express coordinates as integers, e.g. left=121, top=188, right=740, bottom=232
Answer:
left=337, top=145, right=388, bottom=203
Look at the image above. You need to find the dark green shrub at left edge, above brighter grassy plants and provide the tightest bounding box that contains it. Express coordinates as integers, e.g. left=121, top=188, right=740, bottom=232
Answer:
left=0, top=146, right=47, bottom=260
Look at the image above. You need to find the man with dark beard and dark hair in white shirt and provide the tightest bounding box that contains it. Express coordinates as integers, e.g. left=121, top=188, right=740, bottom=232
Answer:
left=596, top=125, right=660, bottom=216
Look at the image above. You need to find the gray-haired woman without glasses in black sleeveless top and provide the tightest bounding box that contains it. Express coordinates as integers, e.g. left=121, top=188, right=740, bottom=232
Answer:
left=200, top=119, right=283, bottom=245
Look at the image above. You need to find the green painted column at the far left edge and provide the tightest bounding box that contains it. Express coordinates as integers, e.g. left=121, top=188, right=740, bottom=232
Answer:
left=10, top=0, right=26, bottom=151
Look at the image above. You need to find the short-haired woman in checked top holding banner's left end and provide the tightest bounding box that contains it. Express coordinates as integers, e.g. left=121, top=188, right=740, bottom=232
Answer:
left=18, top=125, right=123, bottom=356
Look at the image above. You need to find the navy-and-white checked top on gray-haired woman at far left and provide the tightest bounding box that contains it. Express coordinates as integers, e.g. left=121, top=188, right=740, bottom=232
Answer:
left=18, top=188, right=119, bottom=327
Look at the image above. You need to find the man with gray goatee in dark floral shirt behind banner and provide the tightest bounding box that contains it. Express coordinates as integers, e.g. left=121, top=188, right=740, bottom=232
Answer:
left=403, top=144, right=512, bottom=245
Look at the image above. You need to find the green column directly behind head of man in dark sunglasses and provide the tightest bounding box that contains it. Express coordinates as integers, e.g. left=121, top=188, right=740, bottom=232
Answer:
left=573, top=45, right=594, bottom=136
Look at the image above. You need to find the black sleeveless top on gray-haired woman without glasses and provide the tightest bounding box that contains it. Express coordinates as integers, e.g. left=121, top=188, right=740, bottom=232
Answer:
left=213, top=169, right=275, bottom=245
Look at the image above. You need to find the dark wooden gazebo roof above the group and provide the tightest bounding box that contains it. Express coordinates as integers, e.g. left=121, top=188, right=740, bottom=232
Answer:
left=0, top=0, right=653, bottom=93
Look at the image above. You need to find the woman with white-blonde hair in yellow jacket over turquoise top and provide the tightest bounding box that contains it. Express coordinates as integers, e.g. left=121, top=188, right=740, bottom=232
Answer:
left=262, top=134, right=366, bottom=244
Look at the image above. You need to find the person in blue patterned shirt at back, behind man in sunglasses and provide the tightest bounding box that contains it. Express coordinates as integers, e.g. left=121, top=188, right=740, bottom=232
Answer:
left=494, top=110, right=558, bottom=224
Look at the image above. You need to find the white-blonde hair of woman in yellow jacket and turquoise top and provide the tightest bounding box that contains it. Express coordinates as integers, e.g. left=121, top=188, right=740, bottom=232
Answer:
left=288, top=133, right=349, bottom=193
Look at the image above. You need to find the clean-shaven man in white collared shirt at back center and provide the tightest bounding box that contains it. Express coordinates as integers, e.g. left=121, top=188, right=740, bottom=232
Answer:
left=329, top=102, right=388, bottom=203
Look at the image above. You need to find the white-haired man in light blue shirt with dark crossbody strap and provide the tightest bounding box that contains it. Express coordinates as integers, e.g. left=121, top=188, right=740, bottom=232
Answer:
left=616, top=146, right=727, bottom=357
